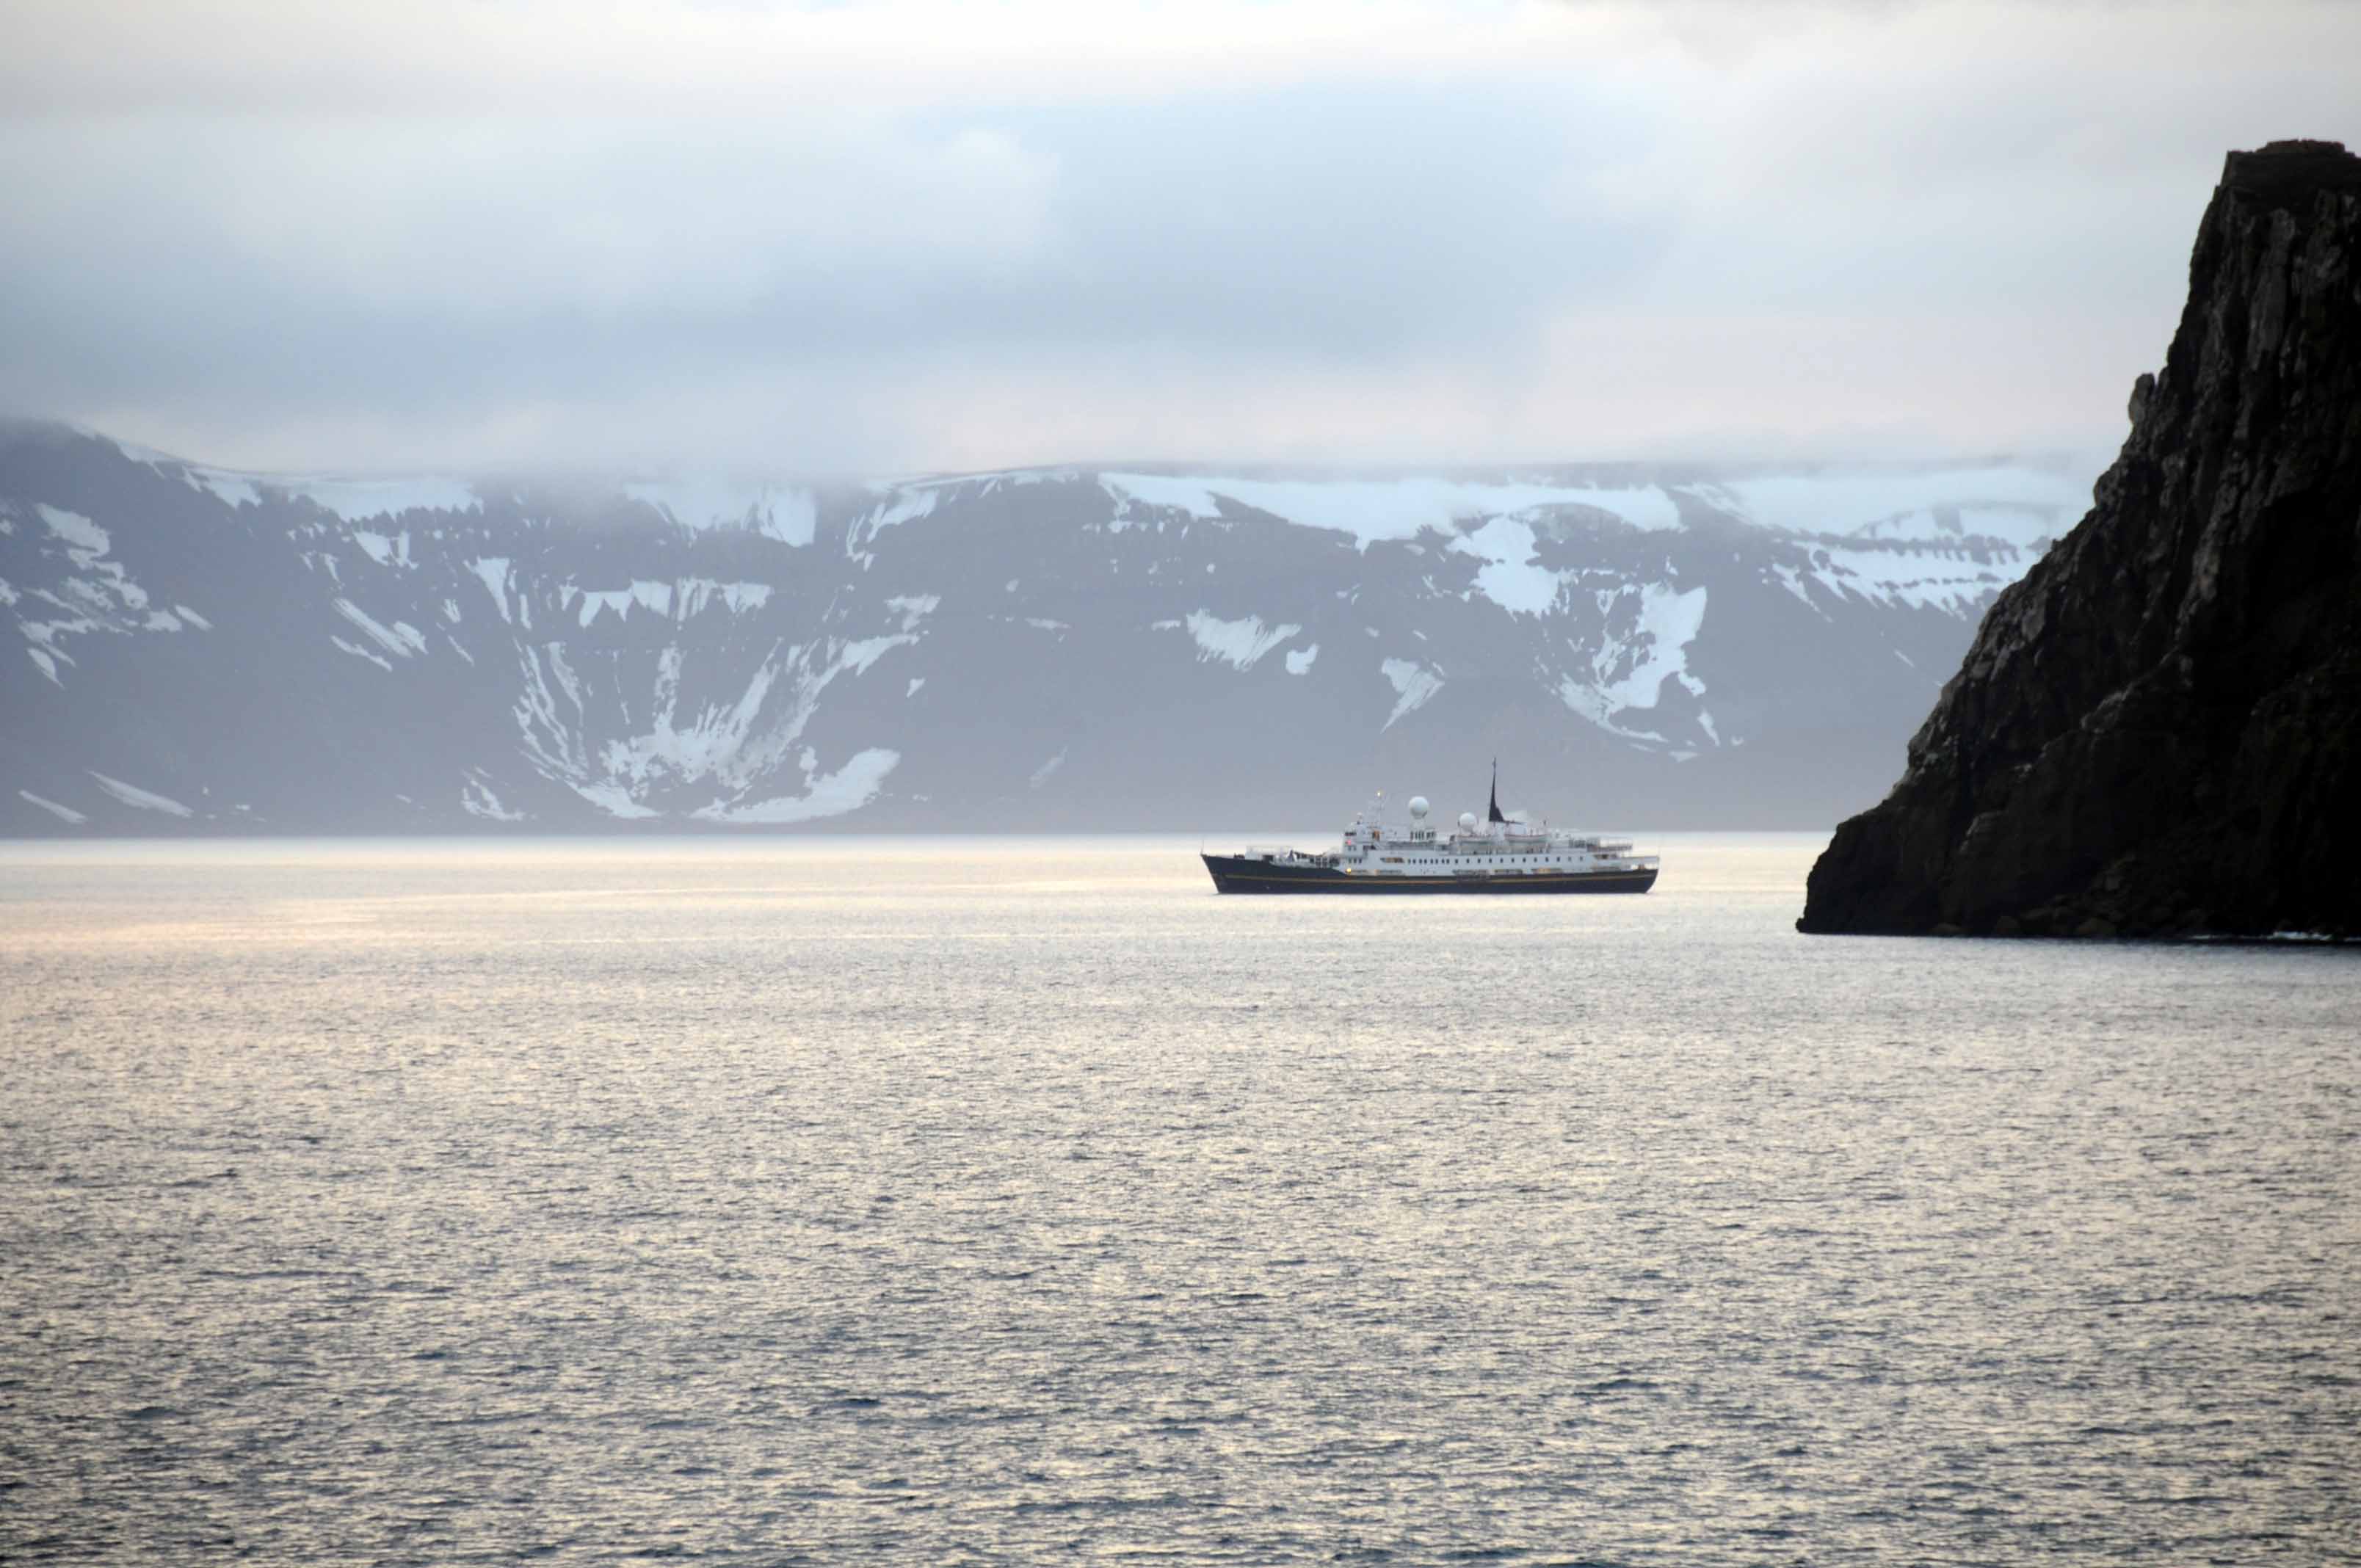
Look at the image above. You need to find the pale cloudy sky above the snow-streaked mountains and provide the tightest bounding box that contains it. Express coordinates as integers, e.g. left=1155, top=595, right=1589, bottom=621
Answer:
left=0, top=0, right=2361, bottom=472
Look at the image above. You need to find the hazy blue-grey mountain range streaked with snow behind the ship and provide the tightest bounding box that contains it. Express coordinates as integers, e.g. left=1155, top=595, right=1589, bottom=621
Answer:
left=0, top=425, right=2087, bottom=834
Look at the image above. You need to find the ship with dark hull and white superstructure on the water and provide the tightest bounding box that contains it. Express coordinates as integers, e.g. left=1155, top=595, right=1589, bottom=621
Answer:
left=1202, top=763, right=1658, bottom=893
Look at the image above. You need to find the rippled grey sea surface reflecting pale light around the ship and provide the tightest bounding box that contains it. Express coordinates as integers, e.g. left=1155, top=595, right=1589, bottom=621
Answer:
left=0, top=838, right=2361, bottom=1564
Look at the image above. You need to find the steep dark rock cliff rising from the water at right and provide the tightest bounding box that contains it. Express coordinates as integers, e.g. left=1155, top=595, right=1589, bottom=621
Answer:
left=1796, top=142, right=2361, bottom=937
